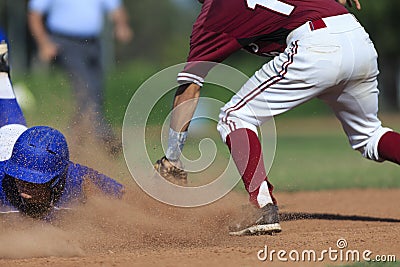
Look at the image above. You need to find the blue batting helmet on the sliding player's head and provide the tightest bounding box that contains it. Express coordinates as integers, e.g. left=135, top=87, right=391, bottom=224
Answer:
left=4, top=126, right=69, bottom=184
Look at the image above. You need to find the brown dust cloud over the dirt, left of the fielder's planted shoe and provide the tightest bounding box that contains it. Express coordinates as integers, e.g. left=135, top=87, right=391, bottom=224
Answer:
left=0, top=185, right=244, bottom=259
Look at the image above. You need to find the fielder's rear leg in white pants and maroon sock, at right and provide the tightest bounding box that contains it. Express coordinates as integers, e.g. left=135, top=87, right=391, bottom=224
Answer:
left=320, top=25, right=400, bottom=168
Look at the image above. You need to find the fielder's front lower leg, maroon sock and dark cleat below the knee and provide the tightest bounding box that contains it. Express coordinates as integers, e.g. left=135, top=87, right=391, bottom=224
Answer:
left=219, top=128, right=281, bottom=236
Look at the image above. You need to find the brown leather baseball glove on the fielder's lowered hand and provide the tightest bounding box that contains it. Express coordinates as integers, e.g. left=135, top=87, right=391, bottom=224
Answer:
left=154, top=156, right=187, bottom=186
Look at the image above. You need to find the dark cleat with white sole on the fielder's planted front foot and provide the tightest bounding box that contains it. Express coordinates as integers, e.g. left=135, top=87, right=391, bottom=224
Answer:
left=229, top=204, right=282, bottom=236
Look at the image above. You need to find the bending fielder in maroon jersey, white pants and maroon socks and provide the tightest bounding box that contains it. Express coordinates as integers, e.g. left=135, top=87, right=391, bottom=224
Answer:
left=155, top=0, right=400, bottom=235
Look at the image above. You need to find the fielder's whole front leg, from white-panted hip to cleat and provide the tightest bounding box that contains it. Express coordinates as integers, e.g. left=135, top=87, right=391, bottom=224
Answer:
left=218, top=31, right=340, bottom=235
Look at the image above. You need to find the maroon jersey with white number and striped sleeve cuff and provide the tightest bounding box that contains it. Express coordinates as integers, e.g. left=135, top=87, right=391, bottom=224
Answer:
left=178, top=0, right=348, bottom=86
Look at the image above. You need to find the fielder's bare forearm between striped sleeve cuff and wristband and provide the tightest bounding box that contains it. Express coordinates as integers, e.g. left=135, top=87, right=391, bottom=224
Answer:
left=171, top=83, right=201, bottom=132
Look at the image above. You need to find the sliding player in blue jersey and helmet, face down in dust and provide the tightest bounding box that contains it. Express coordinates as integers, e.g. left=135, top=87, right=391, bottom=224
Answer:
left=0, top=36, right=123, bottom=219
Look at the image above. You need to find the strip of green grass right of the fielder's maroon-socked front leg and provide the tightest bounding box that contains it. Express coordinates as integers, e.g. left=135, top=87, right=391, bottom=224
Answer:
left=269, top=135, right=400, bottom=191
